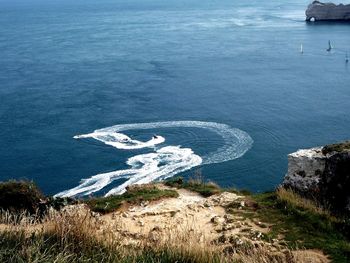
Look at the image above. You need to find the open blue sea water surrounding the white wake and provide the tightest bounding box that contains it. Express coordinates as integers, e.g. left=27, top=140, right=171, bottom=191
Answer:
left=0, top=0, right=350, bottom=198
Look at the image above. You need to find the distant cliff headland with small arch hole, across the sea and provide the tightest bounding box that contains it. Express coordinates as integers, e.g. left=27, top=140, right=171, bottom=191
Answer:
left=305, top=1, right=350, bottom=21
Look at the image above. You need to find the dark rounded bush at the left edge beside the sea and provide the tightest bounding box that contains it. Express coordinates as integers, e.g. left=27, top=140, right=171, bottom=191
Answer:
left=0, top=180, right=45, bottom=214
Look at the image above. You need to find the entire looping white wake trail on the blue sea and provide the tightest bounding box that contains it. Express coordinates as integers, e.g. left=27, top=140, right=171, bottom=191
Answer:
left=55, top=121, right=253, bottom=197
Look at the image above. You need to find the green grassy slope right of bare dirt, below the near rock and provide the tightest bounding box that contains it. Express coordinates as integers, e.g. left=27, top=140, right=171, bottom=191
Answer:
left=235, top=189, right=350, bottom=263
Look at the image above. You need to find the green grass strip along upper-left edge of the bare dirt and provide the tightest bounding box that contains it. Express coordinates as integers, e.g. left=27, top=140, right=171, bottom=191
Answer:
left=85, top=185, right=179, bottom=214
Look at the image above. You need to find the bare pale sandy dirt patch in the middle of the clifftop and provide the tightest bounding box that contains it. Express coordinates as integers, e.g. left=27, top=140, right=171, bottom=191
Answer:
left=101, top=186, right=267, bottom=246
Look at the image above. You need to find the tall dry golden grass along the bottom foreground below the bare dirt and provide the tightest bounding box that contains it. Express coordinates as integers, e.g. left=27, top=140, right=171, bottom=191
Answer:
left=0, top=206, right=326, bottom=263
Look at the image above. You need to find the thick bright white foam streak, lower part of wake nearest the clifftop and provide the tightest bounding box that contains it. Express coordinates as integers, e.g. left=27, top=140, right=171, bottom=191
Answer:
left=55, top=146, right=202, bottom=197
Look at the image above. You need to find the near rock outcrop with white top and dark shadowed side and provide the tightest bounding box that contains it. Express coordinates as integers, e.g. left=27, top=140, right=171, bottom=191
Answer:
left=282, top=143, right=350, bottom=213
